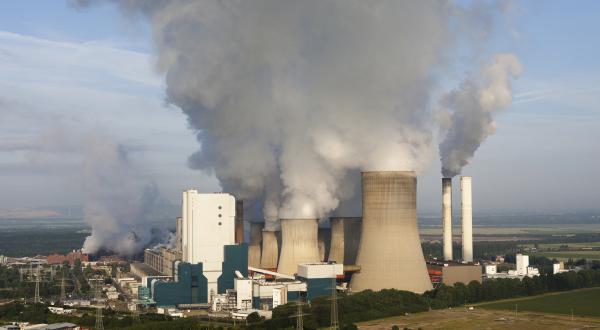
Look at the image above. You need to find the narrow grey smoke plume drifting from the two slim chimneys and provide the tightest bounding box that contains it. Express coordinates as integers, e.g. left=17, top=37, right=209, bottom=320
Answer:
left=440, top=54, right=522, bottom=177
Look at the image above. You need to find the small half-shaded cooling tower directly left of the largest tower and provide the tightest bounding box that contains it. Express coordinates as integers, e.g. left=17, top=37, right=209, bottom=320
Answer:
left=329, top=217, right=362, bottom=265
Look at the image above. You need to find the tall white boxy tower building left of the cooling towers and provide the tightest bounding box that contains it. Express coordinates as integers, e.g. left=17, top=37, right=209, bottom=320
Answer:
left=181, top=190, right=235, bottom=292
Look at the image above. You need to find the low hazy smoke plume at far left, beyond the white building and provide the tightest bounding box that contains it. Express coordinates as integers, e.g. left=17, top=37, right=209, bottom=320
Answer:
left=82, top=135, right=159, bottom=256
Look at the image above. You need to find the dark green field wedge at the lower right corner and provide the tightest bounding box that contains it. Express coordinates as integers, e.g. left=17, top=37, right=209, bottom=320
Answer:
left=479, top=288, right=600, bottom=317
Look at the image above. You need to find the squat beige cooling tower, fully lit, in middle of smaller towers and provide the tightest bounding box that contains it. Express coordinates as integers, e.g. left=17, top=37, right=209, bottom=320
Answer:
left=277, top=219, right=319, bottom=275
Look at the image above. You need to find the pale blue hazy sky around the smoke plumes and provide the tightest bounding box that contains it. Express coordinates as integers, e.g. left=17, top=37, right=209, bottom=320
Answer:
left=0, top=0, right=600, bottom=212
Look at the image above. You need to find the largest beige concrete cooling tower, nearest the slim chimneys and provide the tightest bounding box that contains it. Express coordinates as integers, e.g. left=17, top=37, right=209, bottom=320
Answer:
left=351, top=171, right=432, bottom=293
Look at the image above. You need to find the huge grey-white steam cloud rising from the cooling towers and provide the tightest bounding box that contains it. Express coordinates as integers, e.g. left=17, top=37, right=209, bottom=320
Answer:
left=76, top=0, right=516, bottom=228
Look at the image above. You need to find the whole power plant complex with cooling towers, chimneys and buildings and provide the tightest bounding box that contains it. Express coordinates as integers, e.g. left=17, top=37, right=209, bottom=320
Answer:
left=132, top=171, right=481, bottom=313
